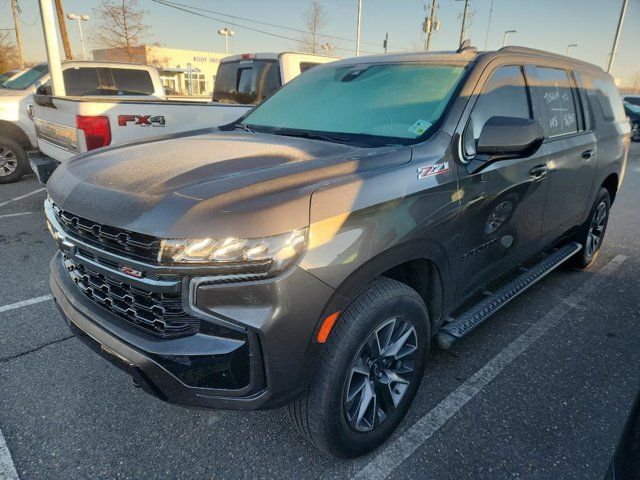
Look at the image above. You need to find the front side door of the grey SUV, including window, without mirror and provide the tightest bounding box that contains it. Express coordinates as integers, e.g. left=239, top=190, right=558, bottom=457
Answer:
left=457, top=65, right=548, bottom=299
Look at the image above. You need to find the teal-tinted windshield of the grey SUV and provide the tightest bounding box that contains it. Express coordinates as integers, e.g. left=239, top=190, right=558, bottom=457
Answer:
left=242, top=63, right=465, bottom=146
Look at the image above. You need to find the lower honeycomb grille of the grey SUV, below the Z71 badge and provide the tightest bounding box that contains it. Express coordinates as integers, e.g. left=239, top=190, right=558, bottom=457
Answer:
left=63, top=255, right=200, bottom=338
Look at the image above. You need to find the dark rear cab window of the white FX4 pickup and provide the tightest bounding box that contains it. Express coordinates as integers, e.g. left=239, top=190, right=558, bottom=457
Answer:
left=213, top=60, right=281, bottom=104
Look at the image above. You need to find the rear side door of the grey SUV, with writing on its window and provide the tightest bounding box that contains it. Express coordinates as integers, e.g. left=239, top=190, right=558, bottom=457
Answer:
left=525, top=65, right=598, bottom=243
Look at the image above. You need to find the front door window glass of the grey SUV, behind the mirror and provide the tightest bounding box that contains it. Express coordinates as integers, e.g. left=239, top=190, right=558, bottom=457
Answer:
left=463, top=65, right=531, bottom=157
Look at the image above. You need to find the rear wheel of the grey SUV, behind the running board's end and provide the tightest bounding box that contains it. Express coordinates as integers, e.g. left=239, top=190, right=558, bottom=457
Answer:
left=569, top=188, right=611, bottom=270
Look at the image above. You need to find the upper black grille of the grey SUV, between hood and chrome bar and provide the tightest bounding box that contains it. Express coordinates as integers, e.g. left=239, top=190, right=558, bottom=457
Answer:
left=52, top=203, right=160, bottom=262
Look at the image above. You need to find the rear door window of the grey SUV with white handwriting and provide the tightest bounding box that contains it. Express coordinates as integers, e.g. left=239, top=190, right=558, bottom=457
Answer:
left=531, top=67, right=578, bottom=137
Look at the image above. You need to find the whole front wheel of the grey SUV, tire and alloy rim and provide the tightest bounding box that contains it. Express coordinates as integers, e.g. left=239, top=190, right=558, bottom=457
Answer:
left=288, top=277, right=430, bottom=458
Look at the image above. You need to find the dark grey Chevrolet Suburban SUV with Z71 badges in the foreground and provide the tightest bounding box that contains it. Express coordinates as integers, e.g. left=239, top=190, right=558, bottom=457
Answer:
left=45, top=47, right=630, bottom=457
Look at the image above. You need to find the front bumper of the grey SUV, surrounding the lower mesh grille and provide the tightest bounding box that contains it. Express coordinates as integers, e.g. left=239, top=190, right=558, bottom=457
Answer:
left=45, top=196, right=335, bottom=409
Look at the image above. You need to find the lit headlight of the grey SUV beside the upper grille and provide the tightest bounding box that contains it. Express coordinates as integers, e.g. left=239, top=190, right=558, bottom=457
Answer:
left=158, top=228, right=307, bottom=275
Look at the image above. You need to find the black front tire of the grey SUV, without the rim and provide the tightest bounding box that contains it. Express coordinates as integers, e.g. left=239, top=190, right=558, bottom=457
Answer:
left=322, top=286, right=429, bottom=457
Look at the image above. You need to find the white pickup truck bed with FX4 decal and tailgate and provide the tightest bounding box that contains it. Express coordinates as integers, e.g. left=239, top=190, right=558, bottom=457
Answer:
left=34, top=96, right=251, bottom=162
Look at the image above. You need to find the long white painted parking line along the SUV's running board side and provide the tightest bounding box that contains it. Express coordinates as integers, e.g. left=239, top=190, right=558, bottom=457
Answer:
left=352, top=255, right=627, bottom=480
